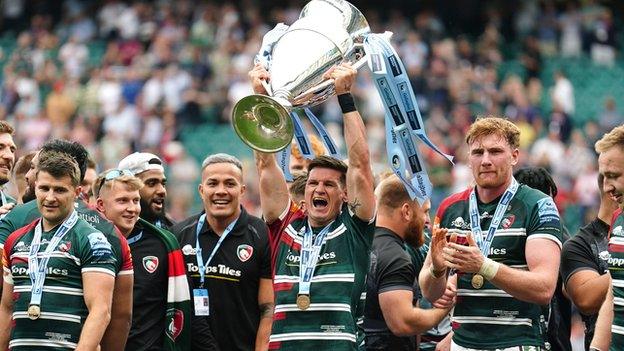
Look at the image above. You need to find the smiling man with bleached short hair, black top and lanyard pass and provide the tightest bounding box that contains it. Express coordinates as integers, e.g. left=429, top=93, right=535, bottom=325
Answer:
left=174, top=154, right=273, bottom=351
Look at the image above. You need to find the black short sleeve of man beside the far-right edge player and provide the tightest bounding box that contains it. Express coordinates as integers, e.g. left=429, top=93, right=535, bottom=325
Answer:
left=559, top=234, right=604, bottom=284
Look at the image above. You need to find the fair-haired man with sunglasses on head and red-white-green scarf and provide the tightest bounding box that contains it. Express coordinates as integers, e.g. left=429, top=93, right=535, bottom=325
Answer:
left=93, top=169, right=202, bottom=351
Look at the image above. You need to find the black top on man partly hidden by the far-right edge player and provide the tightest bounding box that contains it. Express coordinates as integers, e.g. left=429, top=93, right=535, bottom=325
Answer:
left=560, top=218, right=609, bottom=350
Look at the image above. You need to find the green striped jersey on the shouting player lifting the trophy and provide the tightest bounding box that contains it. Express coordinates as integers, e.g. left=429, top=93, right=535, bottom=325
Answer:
left=269, top=202, right=375, bottom=351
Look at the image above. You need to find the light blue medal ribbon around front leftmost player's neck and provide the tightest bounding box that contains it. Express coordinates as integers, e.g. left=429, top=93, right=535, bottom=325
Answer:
left=28, top=210, right=78, bottom=305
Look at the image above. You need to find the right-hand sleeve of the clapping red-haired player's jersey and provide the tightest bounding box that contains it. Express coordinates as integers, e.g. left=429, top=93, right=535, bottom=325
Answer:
left=527, top=196, right=563, bottom=248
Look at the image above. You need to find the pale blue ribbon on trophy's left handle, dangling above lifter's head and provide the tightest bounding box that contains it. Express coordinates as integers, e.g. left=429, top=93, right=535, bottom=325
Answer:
left=254, top=23, right=340, bottom=181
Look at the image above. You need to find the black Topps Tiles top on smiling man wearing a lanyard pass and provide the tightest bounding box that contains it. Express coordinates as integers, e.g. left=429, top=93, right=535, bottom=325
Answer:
left=173, top=208, right=272, bottom=351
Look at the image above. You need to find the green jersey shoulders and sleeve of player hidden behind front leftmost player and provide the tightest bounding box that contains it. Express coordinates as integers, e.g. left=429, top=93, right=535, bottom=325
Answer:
left=0, top=199, right=133, bottom=275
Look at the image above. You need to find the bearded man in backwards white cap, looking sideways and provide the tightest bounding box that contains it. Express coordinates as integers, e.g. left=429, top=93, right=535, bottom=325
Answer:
left=117, top=152, right=173, bottom=231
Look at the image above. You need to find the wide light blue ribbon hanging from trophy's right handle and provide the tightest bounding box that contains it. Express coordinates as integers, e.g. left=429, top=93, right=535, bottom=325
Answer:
left=364, top=32, right=453, bottom=204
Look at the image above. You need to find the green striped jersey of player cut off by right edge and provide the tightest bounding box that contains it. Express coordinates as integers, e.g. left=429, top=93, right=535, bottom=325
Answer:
left=609, top=209, right=624, bottom=351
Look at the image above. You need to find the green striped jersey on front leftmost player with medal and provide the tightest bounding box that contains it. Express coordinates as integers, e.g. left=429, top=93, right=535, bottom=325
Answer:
left=2, top=219, right=117, bottom=351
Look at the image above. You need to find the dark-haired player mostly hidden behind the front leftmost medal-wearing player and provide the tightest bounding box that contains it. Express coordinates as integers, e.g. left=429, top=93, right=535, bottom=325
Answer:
left=0, top=139, right=133, bottom=351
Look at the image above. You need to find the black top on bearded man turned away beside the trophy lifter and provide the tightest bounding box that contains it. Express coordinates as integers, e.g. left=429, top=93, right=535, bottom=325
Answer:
left=364, top=227, right=418, bottom=350
